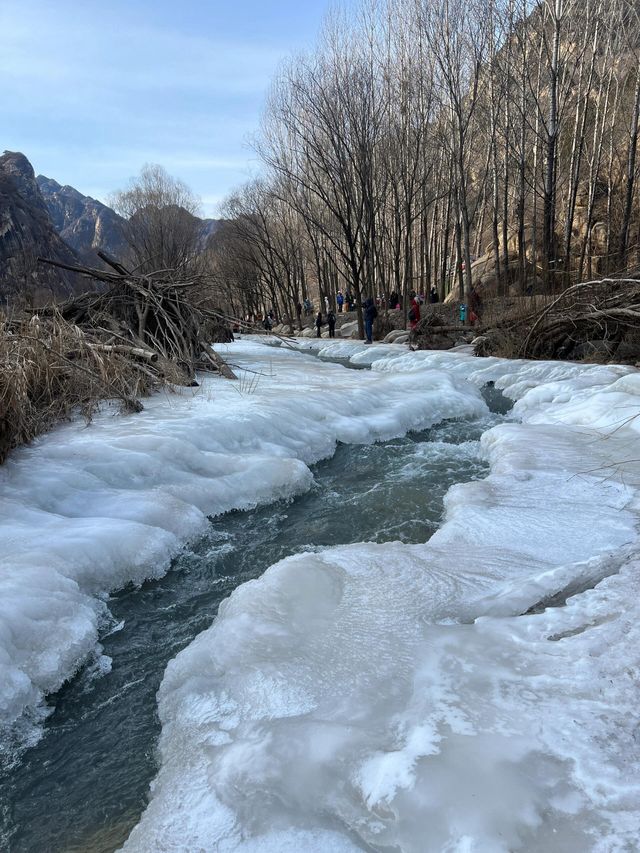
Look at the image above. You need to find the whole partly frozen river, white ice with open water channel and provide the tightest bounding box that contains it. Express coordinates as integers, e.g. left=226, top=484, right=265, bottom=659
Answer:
left=0, top=342, right=640, bottom=853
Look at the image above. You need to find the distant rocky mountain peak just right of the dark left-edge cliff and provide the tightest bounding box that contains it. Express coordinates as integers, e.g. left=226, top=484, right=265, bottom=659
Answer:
left=36, top=175, right=127, bottom=266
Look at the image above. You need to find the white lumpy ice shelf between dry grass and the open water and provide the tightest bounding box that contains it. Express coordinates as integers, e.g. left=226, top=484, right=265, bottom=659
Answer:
left=0, top=342, right=486, bottom=726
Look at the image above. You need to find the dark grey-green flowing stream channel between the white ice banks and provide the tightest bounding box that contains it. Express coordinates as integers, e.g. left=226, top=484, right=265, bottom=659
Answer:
left=0, top=401, right=510, bottom=853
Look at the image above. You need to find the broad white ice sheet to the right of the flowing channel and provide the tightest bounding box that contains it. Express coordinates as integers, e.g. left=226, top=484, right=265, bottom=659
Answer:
left=123, top=341, right=640, bottom=853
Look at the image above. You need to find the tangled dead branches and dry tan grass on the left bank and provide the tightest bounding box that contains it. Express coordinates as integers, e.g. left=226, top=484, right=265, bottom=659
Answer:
left=0, top=255, right=236, bottom=462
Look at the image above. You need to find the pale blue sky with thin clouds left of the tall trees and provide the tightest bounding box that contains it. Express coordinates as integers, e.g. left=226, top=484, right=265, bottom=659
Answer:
left=0, top=0, right=336, bottom=216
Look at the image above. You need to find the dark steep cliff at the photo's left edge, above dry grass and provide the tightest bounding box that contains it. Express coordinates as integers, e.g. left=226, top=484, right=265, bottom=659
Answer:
left=0, top=151, right=86, bottom=304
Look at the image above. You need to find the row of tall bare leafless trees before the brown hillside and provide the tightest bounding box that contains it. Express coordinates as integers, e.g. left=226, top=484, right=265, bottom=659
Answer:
left=210, top=0, right=640, bottom=332
